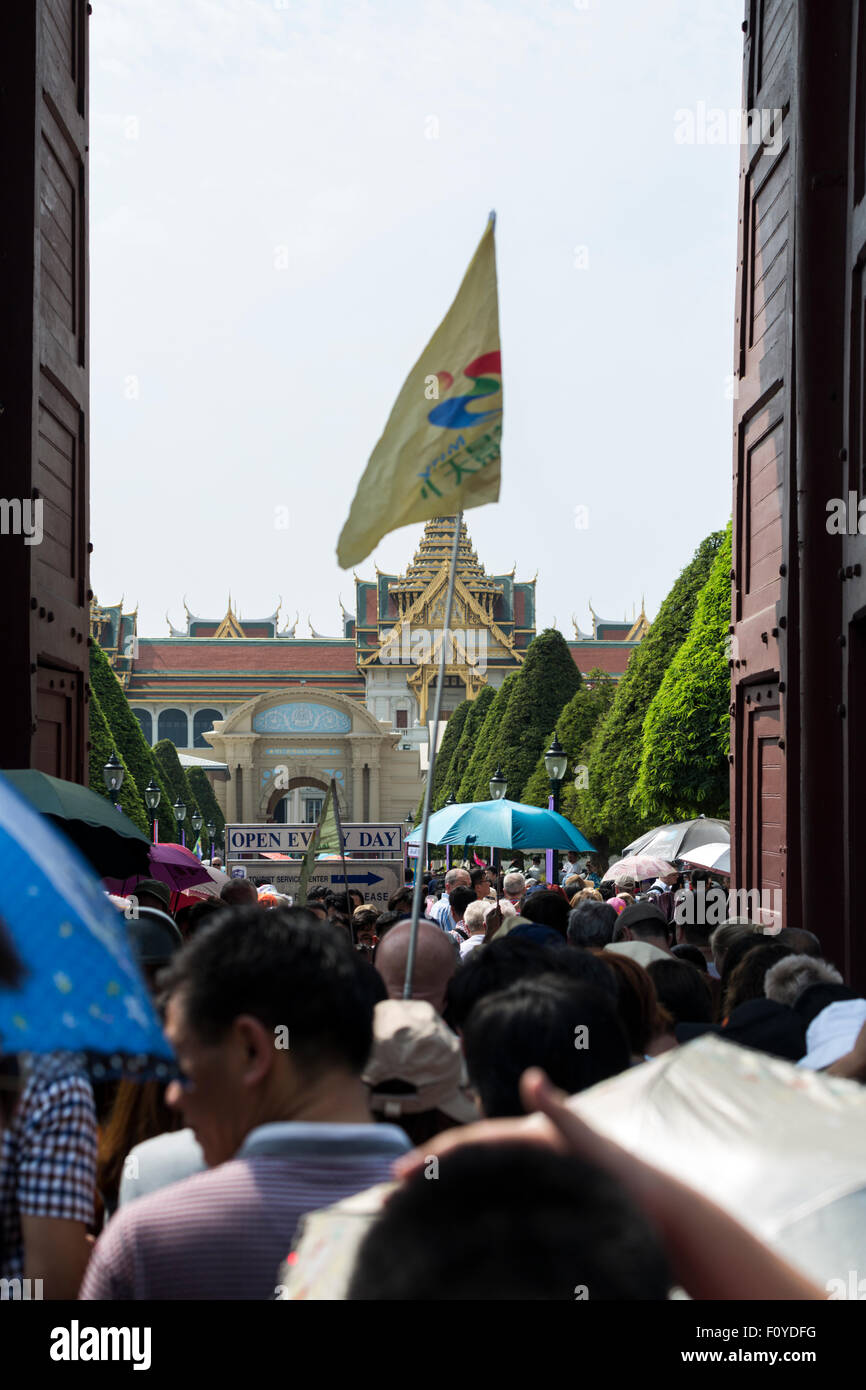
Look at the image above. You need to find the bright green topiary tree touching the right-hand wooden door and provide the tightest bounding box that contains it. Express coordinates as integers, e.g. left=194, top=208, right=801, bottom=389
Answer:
left=632, top=525, right=731, bottom=820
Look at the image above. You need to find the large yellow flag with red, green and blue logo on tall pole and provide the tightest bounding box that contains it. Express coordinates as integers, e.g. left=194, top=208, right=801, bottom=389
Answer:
left=336, top=215, right=502, bottom=569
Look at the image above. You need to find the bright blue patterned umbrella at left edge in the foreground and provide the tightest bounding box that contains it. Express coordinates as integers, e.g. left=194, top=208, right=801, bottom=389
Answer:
left=0, top=776, right=174, bottom=1077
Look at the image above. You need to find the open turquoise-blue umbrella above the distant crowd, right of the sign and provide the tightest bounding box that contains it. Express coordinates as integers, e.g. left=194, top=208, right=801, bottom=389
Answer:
left=406, top=801, right=595, bottom=853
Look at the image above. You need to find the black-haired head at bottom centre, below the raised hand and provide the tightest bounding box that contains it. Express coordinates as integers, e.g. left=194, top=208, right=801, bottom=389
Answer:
left=348, top=1143, right=671, bottom=1302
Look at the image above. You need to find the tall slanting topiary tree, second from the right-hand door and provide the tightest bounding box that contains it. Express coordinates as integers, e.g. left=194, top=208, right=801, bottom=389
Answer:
left=574, top=531, right=724, bottom=851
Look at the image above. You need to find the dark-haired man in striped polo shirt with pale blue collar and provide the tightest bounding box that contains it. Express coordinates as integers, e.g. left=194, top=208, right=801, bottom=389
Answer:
left=81, top=908, right=410, bottom=1300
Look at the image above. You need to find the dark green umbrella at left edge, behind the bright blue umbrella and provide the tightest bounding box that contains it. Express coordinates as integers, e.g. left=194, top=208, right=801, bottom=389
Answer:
left=3, top=767, right=150, bottom=878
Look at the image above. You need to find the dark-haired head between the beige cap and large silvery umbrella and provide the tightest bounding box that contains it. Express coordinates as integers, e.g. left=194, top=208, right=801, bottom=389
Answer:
left=463, top=974, right=631, bottom=1119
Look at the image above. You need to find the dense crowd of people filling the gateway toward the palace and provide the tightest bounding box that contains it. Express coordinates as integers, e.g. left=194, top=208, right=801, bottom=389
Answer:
left=0, top=856, right=866, bottom=1300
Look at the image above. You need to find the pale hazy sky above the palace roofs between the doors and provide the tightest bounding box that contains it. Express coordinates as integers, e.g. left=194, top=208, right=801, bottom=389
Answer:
left=90, top=0, right=744, bottom=637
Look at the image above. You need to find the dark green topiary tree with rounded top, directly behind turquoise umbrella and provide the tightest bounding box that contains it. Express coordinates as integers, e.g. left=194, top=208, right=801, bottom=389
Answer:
left=475, top=627, right=581, bottom=801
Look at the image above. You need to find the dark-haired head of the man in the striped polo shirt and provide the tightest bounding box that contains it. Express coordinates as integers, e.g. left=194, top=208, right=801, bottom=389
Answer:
left=160, top=906, right=373, bottom=1166
